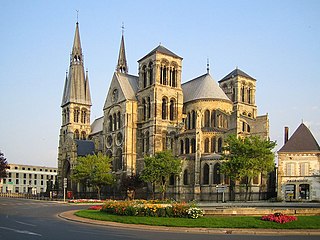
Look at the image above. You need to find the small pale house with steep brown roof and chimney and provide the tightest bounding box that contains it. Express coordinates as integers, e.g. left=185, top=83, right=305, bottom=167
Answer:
left=278, top=123, right=320, bottom=201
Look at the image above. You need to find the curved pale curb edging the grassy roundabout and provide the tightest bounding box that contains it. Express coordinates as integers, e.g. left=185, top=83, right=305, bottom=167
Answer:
left=58, top=210, right=320, bottom=236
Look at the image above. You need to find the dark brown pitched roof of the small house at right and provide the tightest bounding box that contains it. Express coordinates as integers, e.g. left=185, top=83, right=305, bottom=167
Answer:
left=279, top=123, right=320, bottom=152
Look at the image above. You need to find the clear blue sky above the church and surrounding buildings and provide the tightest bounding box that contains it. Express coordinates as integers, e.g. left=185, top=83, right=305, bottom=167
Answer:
left=0, top=0, right=320, bottom=166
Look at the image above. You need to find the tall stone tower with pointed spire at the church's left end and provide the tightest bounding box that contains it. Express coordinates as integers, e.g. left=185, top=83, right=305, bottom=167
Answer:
left=58, top=22, right=91, bottom=192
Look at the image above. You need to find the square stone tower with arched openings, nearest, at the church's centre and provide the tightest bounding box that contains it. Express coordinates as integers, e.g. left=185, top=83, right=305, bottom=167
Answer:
left=137, top=45, right=183, bottom=169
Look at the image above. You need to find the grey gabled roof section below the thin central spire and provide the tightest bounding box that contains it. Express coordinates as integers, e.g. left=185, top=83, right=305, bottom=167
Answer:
left=104, top=72, right=139, bottom=109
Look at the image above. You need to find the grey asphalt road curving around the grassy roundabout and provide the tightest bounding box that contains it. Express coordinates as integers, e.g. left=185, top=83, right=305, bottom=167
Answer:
left=0, top=197, right=319, bottom=240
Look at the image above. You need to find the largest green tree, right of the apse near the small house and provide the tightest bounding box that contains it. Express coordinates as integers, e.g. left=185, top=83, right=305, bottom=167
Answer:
left=221, top=135, right=276, bottom=200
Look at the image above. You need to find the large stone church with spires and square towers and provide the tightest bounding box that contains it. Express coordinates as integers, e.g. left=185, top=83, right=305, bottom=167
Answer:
left=58, top=23, right=269, bottom=200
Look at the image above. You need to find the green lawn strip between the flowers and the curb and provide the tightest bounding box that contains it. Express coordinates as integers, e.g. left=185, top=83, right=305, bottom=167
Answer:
left=75, top=210, right=320, bottom=229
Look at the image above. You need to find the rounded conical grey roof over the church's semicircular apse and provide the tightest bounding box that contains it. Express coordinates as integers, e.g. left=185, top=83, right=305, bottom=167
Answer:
left=182, top=73, right=230, bottom=103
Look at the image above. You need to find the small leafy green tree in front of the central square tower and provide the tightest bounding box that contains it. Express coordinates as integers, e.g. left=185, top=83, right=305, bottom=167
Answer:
left=141, top=151, right=182, bottom=199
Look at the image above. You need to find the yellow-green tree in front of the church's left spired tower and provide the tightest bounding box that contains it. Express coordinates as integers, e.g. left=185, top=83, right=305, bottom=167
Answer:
left=71, top=153, right=113, bottom=199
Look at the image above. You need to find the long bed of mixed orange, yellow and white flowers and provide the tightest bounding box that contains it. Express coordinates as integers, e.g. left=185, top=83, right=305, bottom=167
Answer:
left=101, top=200, right=203, bottom=218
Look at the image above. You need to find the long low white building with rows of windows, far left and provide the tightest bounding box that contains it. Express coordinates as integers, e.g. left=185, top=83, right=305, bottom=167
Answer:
left=0, top=164, right=57, bottom=195
